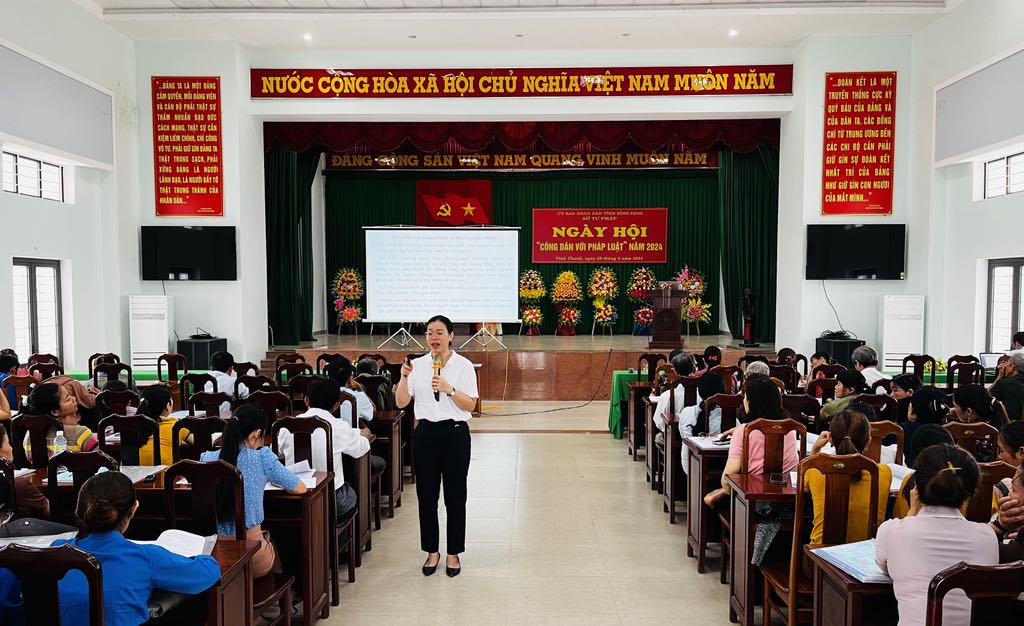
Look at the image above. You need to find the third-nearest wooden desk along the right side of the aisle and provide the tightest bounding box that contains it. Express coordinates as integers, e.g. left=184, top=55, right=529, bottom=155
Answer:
left=683, top=436, right=729, bottom=574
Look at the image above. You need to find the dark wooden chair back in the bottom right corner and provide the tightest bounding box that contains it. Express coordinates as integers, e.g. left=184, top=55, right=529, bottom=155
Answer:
left=925, top=560, right=1024, bottom=626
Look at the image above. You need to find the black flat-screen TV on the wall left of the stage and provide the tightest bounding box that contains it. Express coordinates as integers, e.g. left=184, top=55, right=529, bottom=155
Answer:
left=140, top=226, right=238, bottom=281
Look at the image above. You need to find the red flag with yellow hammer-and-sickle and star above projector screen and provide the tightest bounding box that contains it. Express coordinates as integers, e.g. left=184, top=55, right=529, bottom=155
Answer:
left=416, top=179, right=490, bottom=226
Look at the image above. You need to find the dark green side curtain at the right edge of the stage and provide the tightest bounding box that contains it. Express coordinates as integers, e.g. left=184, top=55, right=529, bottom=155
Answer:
left=718, top=142, right=778, bottom=341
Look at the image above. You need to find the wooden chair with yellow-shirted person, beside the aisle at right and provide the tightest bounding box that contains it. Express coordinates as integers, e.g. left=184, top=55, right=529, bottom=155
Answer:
left=761, top=454, right=881, bottom=626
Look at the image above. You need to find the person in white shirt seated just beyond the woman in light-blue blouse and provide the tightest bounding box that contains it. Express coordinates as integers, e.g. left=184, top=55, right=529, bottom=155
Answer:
left=278, top=380, right=372, bottom=515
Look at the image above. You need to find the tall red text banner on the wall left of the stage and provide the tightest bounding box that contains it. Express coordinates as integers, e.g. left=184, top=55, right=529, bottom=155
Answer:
left=152, top=76, right=224, bottom=217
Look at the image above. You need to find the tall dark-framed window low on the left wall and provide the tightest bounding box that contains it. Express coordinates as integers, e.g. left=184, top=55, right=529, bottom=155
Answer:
left=12, top=258, right=63, bottom=359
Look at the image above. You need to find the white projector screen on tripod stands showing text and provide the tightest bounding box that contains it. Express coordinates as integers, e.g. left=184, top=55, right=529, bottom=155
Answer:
left=364, top=226, right=519, bottom=323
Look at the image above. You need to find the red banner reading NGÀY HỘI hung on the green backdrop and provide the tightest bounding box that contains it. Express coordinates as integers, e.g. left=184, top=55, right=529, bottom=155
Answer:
left=534, top=209, right=669, bottom=264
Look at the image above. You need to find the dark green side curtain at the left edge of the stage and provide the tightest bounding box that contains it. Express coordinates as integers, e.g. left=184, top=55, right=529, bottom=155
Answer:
left=264, top=143, right=321, bottom=345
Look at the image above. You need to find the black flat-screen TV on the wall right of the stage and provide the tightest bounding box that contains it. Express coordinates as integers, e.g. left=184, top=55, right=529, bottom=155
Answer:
left=807, top=224, right=906, bottom=281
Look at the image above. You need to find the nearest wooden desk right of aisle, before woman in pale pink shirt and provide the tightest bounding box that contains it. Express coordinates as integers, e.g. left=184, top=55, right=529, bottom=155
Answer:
left=804, top=546, right=899, bottom=626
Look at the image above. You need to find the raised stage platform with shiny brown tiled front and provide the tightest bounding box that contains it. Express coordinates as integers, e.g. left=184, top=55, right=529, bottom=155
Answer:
left=263, top=334, right=774, bottom=402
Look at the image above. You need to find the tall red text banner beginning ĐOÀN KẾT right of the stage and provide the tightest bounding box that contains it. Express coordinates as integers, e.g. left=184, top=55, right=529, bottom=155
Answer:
left=821, top=72, right=896, bottom=215
